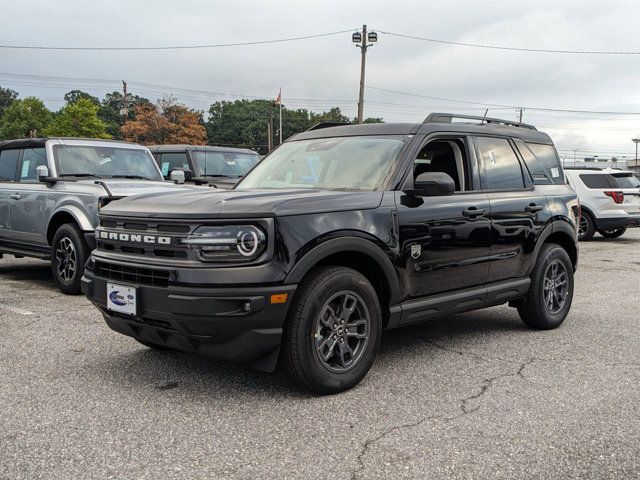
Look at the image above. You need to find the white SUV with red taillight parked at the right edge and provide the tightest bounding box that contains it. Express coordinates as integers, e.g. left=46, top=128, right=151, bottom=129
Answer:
left=565, top=167, right=640, bottom=240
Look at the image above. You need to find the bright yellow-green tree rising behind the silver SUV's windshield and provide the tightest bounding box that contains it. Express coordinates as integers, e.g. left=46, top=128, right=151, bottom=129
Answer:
left=44, top=98, right=111, bottom=138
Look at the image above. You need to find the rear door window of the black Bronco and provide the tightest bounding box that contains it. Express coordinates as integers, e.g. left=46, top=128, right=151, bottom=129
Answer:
left=474, top=137, right=525, bottom=190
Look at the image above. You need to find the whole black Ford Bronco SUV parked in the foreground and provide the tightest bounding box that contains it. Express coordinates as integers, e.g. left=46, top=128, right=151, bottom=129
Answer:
left=83, top=114, right=580, bottom=393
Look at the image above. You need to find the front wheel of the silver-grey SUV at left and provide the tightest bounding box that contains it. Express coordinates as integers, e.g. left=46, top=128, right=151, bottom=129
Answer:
left=51, top=223, right=91, bottom=295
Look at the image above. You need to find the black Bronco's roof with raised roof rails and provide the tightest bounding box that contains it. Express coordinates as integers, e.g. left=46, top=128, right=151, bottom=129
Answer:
left=287, top=113, right=553, bottom=145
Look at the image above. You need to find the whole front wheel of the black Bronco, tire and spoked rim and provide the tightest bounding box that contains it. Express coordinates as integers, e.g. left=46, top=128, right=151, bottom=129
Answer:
left=282, top=267, right=382, bottom=395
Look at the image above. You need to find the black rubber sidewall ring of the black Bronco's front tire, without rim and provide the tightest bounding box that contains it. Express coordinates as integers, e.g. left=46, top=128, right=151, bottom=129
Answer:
left=296, top=269, right=382, bottom=392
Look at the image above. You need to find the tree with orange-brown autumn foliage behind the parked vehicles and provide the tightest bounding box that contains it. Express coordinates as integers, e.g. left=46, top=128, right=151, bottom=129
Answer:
left=122, top=98, right=207, bottom=145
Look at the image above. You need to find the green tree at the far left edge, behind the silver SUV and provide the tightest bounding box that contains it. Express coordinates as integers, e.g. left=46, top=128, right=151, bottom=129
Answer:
left=0, top=97, right=52, bottom=139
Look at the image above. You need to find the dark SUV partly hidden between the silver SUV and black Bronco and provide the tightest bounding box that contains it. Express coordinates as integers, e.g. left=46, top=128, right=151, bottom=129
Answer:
left=149, top=145, right=260, bottom=189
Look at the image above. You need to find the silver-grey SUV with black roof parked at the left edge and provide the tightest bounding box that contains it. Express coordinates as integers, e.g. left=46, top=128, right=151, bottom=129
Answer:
left=0, top=138, right=190, bottom=294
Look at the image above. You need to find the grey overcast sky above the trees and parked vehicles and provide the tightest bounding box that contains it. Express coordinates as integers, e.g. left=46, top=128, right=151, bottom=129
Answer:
left=0, top=0, right=640, bottom=156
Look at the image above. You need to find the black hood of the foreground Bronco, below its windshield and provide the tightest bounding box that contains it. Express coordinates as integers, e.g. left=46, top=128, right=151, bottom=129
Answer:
left=101, top=188, right=382, bottom=218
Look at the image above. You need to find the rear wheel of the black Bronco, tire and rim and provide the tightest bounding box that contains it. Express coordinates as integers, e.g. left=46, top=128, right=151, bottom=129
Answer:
left=518, top=243, right=574, bottom=330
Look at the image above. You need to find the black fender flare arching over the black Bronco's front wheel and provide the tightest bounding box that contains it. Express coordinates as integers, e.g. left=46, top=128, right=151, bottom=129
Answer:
left=285, top=237, right=400, bottom=305
